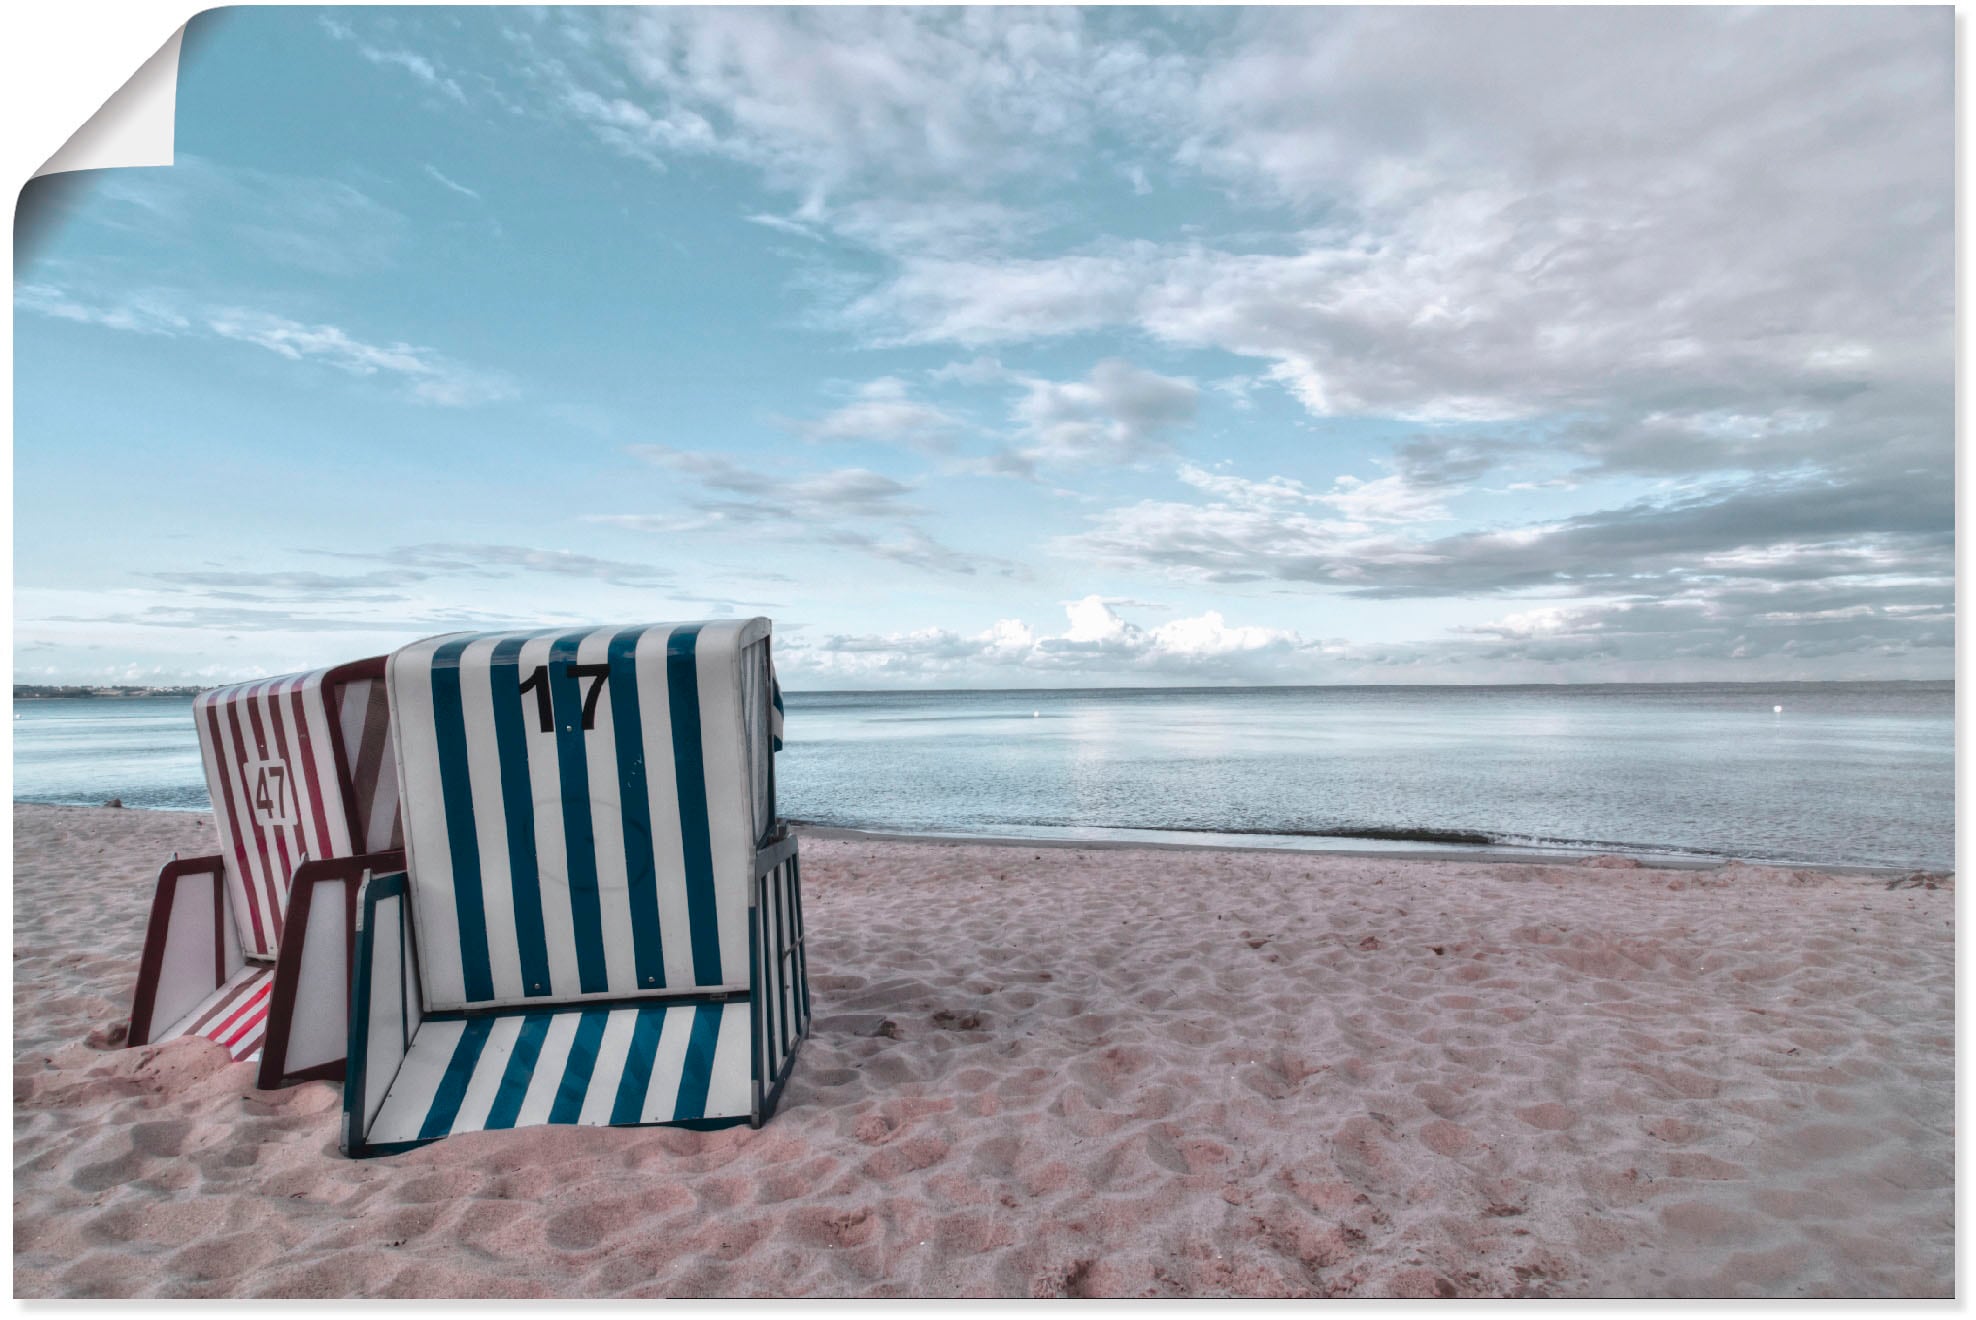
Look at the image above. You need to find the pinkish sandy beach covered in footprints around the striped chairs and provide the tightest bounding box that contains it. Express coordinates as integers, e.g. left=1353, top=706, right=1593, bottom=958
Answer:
left=14, top=806, right=1954, bottom=1296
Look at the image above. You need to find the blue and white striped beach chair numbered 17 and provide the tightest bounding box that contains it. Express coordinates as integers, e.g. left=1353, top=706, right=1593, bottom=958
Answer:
left=342, top=619, right=810, bottom=1156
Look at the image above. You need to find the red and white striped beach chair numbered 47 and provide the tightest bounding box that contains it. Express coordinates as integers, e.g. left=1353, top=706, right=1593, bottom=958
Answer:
left=126, top=656, right=403, bottom=1087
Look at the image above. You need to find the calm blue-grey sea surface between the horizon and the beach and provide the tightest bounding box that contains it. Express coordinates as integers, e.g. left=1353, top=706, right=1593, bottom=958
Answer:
left=14, top=682, right=1954, bottom=867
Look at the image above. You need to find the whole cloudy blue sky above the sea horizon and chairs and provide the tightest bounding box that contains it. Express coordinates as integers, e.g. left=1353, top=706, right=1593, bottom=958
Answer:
left=14, top=6, right=1954, bottom=690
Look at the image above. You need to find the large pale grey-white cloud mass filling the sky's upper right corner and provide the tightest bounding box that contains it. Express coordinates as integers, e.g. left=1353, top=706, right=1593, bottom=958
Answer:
left=802, top=10, right=1954, bottom=490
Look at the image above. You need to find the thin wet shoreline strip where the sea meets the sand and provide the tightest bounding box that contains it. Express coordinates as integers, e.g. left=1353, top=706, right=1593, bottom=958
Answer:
left=14, top=798, right=1954, bottom=877
